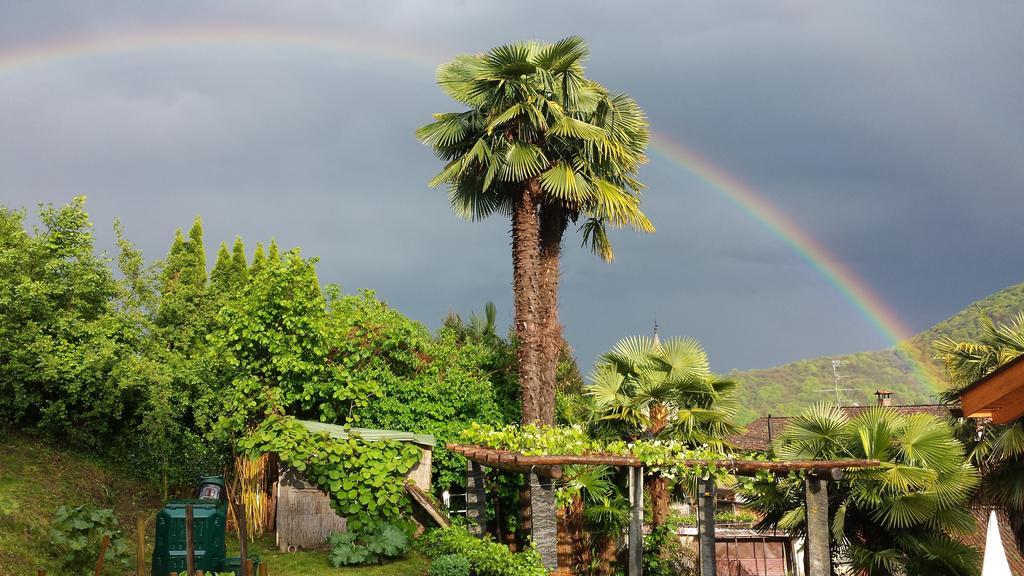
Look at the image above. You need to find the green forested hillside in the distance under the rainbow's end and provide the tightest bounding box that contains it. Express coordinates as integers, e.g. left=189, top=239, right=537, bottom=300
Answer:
left=729, top=284, right=1024, bottom=421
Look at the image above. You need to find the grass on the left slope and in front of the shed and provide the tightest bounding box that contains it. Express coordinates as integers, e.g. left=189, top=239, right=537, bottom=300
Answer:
left=0, top=429, right=428, bottom=576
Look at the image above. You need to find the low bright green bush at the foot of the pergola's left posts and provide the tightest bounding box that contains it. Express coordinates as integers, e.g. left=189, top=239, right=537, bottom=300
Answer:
left=420, top=526, right=548, bottom=576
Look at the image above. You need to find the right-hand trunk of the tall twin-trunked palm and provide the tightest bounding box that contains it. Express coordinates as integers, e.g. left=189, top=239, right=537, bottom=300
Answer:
left=538, top=205, right=568, bottom=425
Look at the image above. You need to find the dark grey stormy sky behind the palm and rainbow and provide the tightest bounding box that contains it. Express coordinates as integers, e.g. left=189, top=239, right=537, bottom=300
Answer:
left=0, top=0, right=1024, bottom=371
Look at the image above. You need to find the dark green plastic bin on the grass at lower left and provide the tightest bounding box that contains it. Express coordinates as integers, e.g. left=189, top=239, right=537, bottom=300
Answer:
left=153, top=477, right=227, bottom=576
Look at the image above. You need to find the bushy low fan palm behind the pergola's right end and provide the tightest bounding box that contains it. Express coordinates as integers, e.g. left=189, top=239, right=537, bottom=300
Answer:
left=741, top=404, right=980, bottom=576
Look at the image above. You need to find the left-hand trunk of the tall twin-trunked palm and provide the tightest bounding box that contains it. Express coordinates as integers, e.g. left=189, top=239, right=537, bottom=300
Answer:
left=512, top=179, right=543, bottom=424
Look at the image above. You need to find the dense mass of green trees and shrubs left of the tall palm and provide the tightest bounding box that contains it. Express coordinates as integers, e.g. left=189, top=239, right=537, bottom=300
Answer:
left=0, top=198, right=518, bottom=502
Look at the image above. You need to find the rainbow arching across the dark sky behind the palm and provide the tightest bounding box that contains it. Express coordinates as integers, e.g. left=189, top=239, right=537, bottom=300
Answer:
left=0, top=27, right=941, bottom=390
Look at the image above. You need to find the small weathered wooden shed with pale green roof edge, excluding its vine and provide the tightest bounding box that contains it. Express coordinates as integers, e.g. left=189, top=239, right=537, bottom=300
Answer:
left=276, top=420, right=435, bottom=551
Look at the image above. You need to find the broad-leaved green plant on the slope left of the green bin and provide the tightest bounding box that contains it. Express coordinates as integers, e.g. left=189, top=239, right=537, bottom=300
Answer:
left=50, top=504, right=128, bottom=573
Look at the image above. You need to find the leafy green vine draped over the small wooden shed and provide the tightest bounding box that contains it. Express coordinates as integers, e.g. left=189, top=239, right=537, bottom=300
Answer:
left=238, top=416, right=420, bottom=530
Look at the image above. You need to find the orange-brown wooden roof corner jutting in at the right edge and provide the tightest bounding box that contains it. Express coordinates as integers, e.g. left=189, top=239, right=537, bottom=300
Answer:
left=959, top=356, right=1024, bottom=424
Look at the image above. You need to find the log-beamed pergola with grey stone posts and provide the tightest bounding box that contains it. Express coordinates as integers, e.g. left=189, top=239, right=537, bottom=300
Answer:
left=447, top=444, right=879, bottom=576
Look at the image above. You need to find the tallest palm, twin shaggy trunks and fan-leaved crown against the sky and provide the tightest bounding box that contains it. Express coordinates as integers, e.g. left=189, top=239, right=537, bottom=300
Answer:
left=417, top=37, right=653, bottom=424
